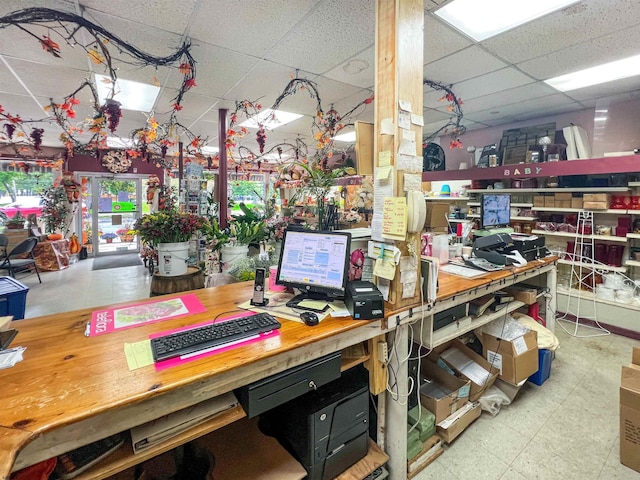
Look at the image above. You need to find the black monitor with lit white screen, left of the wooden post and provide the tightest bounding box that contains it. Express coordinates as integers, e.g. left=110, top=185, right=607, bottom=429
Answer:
left=276, top=230, right=351, bottom=310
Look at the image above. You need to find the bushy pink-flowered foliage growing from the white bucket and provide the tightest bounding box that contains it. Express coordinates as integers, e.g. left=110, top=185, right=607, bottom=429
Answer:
left=133, top=210, right=208, bottom=247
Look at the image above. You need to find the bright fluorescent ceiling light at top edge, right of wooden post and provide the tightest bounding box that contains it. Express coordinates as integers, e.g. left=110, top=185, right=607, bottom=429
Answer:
left=435, top=0, right=580, bottom=42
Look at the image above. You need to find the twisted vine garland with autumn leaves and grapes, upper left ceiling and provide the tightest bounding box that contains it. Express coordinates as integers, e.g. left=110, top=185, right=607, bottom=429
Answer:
left=0, top=8, right=200, bottom=161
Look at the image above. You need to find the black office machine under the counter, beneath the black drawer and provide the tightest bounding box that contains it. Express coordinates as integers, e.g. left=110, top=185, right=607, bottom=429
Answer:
left=260, top=367, right=369, bottom=480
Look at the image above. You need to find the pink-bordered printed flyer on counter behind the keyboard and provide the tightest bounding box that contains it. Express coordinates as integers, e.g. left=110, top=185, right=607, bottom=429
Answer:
left=89, top=293, right=206, bottom=337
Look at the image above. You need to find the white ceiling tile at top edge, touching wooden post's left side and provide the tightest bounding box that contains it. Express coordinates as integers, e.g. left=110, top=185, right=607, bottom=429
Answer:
left=266, top=0, right=375, bottom=73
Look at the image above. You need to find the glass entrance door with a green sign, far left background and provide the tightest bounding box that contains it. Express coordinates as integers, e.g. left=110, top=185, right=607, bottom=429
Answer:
left=81, top=175, right=142, bottom=256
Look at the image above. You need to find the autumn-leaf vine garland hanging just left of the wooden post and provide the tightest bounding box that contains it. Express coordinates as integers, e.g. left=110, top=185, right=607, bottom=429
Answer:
left=226, top=75, right=374, bottom=178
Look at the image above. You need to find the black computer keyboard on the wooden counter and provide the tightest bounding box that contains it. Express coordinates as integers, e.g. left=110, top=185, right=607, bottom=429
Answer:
left=151, top=313, right=280, bottom=362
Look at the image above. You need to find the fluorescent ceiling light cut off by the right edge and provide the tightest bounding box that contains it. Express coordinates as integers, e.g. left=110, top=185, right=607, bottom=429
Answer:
left=545, top=55, right=640, bottom=92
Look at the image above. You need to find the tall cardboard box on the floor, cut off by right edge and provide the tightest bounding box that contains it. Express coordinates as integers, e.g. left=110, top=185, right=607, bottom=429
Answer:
left=620, top=347, right=640, bottom=472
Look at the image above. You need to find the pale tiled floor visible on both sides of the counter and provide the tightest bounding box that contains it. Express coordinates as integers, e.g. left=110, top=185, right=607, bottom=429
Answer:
left=13, top=259, right=640, bottom=480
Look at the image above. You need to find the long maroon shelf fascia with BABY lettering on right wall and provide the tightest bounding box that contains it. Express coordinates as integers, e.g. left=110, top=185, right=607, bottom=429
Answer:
left=422, top=155, right=640, bottom=182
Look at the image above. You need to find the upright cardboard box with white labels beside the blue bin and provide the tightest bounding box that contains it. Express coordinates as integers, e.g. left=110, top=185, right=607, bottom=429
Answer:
left=479, top=330, right=538, bottom=384
